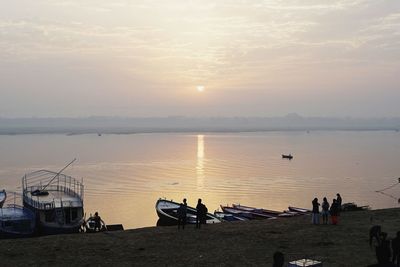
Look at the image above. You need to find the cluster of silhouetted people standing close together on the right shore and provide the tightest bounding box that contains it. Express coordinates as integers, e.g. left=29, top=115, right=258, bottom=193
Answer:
left=312, top=193, right=342, bottom=225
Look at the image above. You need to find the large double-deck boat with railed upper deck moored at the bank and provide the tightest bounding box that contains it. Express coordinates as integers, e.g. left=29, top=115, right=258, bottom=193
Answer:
left=22, top=170, right=84, bottom=234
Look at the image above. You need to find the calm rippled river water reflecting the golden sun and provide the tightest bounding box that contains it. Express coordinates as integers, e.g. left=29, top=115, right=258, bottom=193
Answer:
left=0, top=131, right=400, bottom=228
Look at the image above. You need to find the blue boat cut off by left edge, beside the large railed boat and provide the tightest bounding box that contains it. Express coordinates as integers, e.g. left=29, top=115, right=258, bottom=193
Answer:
left=0, top=192, right=36, bottom=238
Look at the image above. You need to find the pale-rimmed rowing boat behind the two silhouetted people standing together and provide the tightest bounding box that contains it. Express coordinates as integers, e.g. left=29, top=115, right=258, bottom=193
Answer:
left=156, top=198, right=221, bottom=225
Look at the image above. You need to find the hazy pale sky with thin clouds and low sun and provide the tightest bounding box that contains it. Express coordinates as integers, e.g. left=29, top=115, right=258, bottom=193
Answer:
left=0, top=0, right=400, bottom=117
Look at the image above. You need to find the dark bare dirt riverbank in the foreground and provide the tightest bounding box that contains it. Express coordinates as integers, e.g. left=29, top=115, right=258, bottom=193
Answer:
left=0, top=209, right=400, bottom=267
